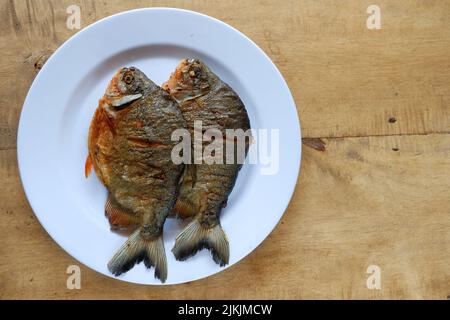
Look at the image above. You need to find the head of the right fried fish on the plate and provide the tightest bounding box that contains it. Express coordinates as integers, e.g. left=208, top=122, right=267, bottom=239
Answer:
left=163, top=59, right=212, bottom=102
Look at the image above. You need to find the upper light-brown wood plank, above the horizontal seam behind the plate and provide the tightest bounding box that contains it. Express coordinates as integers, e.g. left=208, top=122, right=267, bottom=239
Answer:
left=0, top=0, right=450, bottom=149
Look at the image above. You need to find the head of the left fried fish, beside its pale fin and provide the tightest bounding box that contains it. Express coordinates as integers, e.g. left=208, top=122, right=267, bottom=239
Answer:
left=101, top=67, right=149, bottom=115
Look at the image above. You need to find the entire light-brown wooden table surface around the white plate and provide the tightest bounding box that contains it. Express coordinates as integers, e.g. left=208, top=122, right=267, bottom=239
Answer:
left=0, top=0, right=450, bottom=299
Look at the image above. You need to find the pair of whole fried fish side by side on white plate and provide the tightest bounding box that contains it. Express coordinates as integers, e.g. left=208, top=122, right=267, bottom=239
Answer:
left=85, top=59, right=250, bottom=282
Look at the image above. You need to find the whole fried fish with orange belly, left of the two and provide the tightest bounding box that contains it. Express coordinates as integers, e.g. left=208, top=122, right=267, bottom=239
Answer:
left=85, top=67, right=186, bottom=282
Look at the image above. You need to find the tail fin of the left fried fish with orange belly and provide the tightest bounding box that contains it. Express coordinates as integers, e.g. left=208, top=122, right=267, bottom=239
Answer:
left=108, top=228, right=167, bottom=282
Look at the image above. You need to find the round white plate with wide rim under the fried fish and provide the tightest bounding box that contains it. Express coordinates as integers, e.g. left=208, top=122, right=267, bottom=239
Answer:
left=17, top=8, right=301, bottom=285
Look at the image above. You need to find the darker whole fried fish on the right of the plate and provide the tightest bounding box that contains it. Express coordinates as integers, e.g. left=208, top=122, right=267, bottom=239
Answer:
left=163, top=59, right=250, bottom=266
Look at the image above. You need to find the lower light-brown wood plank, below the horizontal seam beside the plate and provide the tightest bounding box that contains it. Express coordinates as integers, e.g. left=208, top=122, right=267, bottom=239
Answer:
left=0, top=135, right=450, bottom=299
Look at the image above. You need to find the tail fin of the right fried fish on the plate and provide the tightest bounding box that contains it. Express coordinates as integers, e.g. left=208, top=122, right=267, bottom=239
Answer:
left=172, top=219, right=230, bottom=266
